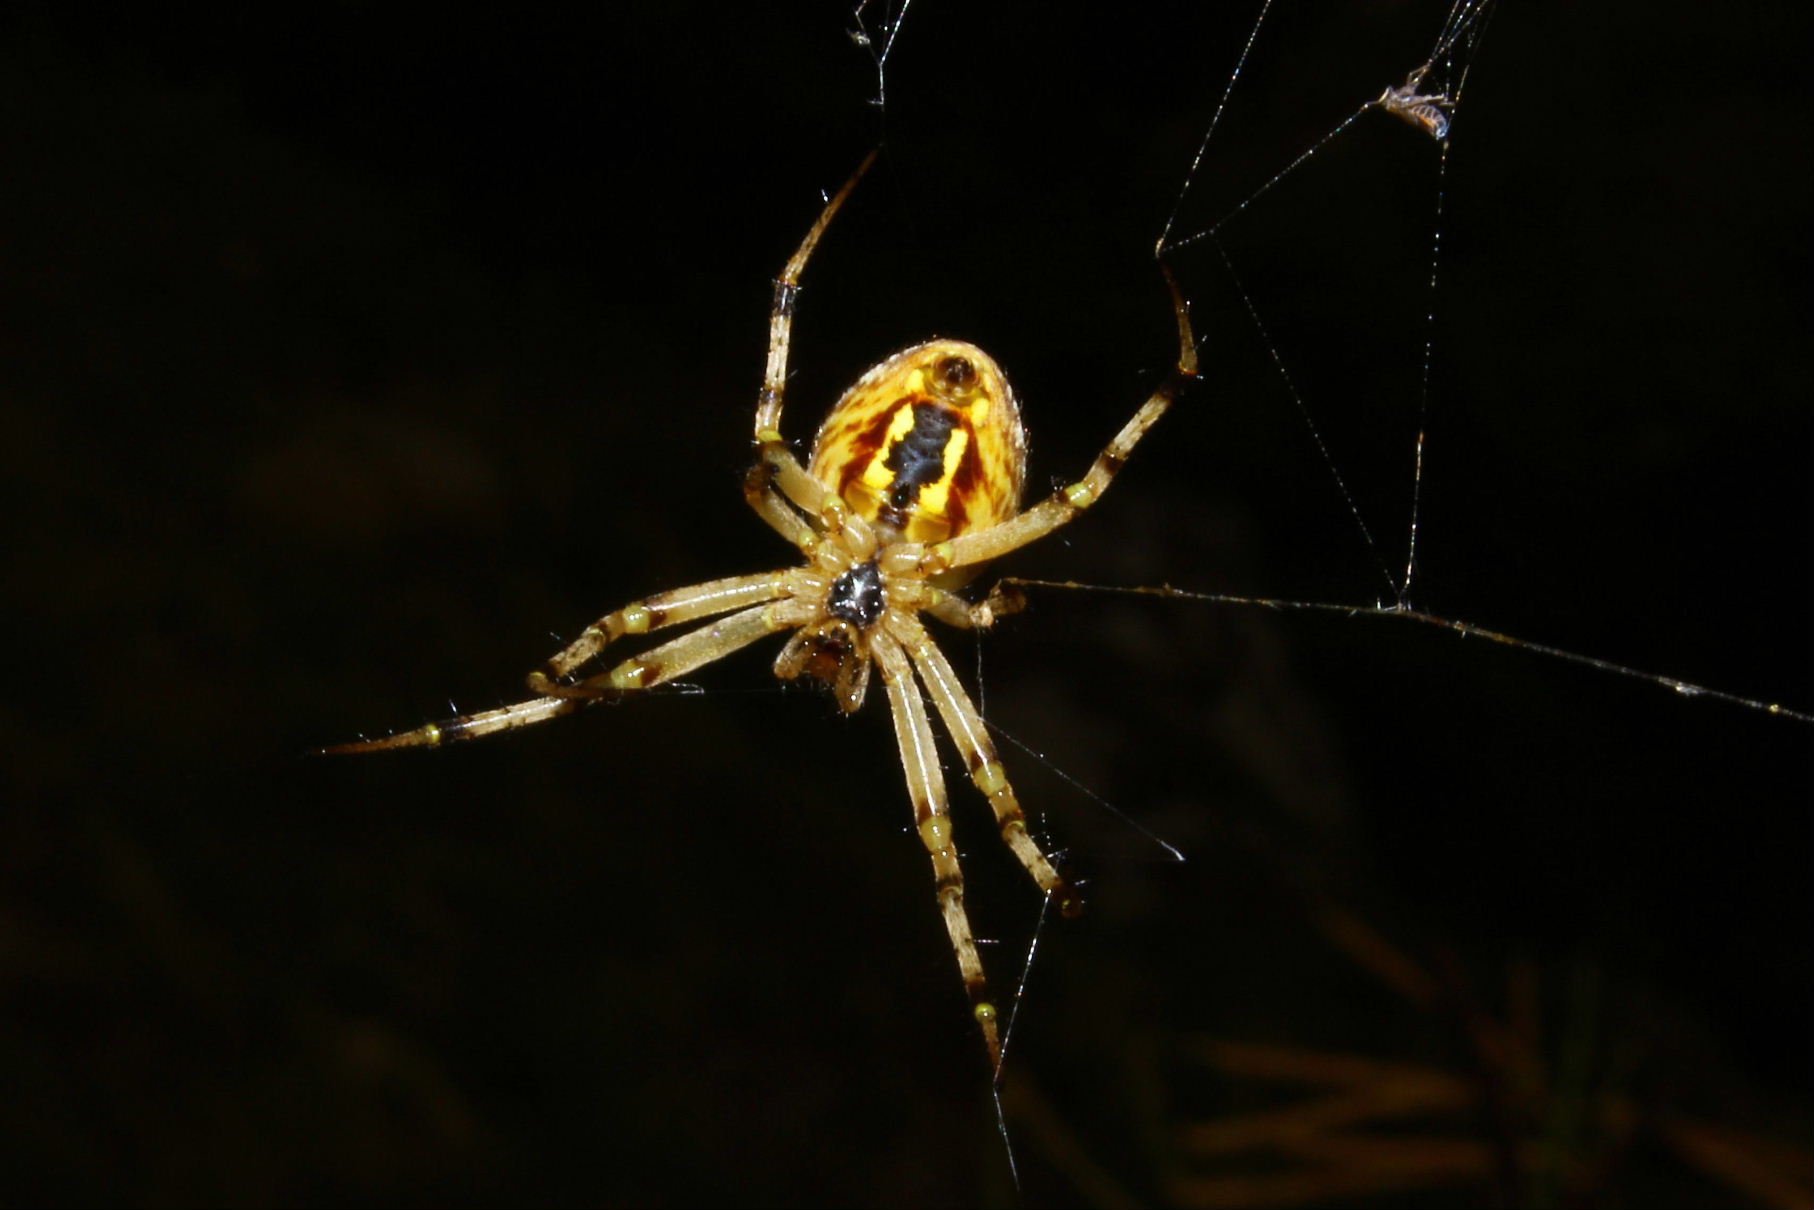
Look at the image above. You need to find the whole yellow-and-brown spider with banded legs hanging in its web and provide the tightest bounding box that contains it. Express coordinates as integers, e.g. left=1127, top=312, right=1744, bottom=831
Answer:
left=321, top=152, right=1197, bottom=1069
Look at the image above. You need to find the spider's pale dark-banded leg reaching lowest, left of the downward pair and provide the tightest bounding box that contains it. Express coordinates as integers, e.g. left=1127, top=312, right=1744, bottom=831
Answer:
left=871, top=631, right=1001, bottom=1067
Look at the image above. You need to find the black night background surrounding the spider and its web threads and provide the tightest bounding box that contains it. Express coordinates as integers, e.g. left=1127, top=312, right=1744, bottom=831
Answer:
left=0, top=2, right=1814, bottom=1205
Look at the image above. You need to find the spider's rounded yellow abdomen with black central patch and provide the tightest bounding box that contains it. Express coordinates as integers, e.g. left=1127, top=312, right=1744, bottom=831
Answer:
left=811, top=341, right=1027, bottom=542
